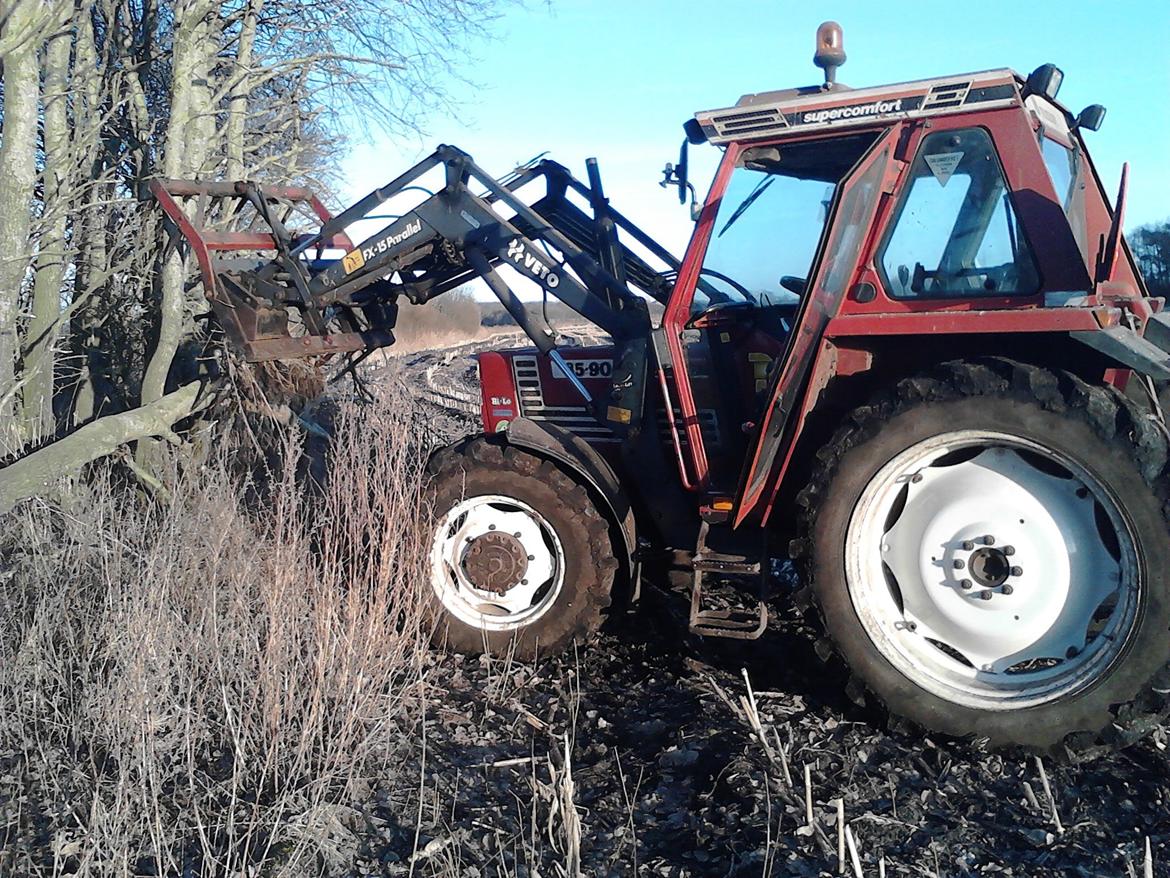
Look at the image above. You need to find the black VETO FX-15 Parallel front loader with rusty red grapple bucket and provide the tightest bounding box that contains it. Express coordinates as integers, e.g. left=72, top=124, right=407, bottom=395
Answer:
left=150, top=146, right=679, bottom=433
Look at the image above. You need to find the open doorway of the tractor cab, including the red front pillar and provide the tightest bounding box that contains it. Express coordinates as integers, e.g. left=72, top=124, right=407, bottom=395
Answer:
left=655, top=129, right=882, bottom=501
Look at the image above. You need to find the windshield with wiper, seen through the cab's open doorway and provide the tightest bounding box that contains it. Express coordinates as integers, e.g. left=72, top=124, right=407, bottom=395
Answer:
left=691, top=128, right=873, bottom=313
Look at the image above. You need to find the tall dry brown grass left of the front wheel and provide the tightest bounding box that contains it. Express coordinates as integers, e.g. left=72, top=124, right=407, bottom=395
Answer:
left=0, top=402, right=427, bottom=876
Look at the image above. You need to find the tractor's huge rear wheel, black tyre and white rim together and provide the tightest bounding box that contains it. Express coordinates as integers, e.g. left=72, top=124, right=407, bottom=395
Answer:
left=801, top=359, right=1170, bottom=750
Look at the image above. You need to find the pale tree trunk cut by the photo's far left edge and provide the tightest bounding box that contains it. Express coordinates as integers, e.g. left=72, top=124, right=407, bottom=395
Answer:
left=0, top=2, right=41, bottom=440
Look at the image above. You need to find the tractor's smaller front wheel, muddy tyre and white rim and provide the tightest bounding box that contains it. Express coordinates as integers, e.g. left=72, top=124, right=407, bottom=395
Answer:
left=427, top=438, right=618, bottom=659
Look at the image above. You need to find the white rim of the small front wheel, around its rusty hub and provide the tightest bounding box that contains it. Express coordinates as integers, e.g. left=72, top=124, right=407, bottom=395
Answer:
left=431, top=494, right=565, bottom=631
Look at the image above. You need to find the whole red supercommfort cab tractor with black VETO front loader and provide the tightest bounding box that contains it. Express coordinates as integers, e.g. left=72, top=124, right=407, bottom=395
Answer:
left=154, top=22, right=1170, bottom=748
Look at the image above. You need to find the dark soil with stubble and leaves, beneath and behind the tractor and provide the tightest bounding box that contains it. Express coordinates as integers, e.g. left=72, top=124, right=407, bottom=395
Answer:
left=366, top=336, right=1170, bottom=878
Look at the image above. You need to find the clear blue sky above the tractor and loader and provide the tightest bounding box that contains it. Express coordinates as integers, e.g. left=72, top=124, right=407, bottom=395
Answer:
left=343, top=0, right=1170, bottom=261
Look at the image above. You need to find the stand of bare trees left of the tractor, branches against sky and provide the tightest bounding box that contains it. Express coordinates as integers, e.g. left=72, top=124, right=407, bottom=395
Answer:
left=0, top=0, right=508, bottom=498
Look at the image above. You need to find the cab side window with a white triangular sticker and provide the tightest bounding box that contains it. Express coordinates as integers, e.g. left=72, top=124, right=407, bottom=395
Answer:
left=879, top=128, right=1040, bottom=299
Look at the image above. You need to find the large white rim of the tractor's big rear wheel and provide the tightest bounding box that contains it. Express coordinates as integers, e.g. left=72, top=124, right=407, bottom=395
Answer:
left=846, top=431, right=1141, bottom=709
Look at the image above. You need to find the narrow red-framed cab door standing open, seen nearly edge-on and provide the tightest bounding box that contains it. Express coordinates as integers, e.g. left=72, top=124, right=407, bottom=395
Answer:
left=735, top=125, right=902, bottom=526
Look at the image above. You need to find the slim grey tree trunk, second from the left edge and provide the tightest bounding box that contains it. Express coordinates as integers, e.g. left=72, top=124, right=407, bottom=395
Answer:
left=22, top=13, right=73, bottom=441
